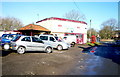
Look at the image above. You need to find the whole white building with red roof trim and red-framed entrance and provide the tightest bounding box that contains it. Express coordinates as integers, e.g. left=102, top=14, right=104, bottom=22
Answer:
left=36, top=17, right=87, bottom=44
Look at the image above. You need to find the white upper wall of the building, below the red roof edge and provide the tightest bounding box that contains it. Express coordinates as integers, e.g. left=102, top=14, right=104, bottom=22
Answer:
left=37, top=20, right=87, bottom=43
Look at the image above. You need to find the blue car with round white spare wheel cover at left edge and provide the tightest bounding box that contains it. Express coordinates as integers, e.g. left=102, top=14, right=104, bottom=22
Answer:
left=0, top=34, right=19, bottom=50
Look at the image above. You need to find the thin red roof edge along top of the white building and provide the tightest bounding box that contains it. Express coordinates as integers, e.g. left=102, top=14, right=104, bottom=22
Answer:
left=36, top=17, right=87, bottom=25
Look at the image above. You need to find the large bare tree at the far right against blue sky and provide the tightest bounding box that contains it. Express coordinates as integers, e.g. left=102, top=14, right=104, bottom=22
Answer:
left=99, top=18, right=118, bottom=39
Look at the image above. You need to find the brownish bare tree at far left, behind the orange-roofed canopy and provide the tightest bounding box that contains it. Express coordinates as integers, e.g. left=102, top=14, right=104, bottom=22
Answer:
left=0, top=17, right=23, bottom=30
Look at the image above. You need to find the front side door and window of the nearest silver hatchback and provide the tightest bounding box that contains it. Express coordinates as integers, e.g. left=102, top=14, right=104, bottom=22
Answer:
left=32, top=37, right=45, bottom=51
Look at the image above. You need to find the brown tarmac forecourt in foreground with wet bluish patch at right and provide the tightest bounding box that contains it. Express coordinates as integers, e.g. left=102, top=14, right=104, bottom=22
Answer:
left=1, top=45, right=119, bottom=75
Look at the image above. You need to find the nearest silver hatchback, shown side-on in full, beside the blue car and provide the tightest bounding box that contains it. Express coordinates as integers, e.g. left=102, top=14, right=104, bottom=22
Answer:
left=11, top=36, right=53, bottom=54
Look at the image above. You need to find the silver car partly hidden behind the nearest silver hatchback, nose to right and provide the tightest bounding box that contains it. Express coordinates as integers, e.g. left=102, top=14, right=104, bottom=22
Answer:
left=39, top=34, right=70, bottom=50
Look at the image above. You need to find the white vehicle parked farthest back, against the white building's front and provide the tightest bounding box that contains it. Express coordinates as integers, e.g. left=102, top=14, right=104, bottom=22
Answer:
left=63, top=35, right=77, bottom=47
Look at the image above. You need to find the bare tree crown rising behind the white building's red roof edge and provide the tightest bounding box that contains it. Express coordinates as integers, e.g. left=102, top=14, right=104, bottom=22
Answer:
left=64, top=10, right=85, bottom=20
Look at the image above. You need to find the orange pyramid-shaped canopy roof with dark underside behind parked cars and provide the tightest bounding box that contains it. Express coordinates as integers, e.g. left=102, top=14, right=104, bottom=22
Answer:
left=18, top=24, right=51, bottom=36
